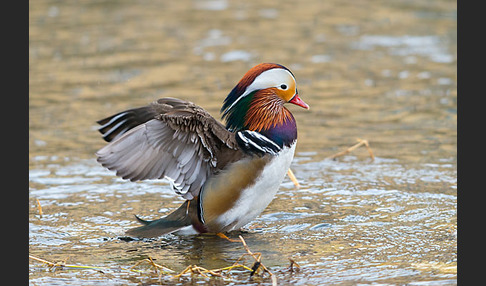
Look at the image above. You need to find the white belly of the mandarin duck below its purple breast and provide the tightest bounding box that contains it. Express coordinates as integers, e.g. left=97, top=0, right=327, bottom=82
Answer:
left=217, top=142, right=296, bottom=231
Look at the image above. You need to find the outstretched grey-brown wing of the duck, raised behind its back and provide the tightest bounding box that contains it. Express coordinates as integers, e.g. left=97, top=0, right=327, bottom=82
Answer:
left=96, top=98, right=242, bottom=199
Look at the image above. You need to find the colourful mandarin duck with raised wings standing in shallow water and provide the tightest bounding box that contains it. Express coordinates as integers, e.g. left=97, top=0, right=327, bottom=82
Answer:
left=96, top=63, right=309, bottom=237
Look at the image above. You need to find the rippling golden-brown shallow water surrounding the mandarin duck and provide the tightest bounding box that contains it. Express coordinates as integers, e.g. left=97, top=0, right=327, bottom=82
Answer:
left=29, top=0, right=457, bottom=285
